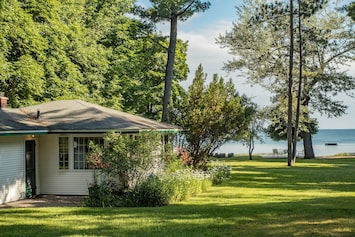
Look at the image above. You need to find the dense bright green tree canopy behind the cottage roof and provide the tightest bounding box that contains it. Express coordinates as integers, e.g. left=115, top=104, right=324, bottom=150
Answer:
left=0, top=0, right=188, bottom=118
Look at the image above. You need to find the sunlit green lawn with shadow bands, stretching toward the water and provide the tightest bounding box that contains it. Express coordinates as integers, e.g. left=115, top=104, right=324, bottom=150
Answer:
left=0, top=158, right=355, bottom=237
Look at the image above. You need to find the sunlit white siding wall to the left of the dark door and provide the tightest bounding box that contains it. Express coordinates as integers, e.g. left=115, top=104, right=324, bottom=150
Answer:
left=0, top=136, right=26, bottom=204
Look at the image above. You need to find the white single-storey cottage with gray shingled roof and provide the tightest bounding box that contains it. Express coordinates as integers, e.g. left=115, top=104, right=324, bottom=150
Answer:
left=0, top=96, right=179, bottom=204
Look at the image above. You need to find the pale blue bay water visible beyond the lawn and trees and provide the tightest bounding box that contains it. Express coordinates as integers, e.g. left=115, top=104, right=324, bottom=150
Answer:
left=216, top=129, right=355, bottom=157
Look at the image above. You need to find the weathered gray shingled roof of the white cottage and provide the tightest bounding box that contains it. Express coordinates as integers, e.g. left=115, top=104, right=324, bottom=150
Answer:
left=0, top=100, right=179, bottom=135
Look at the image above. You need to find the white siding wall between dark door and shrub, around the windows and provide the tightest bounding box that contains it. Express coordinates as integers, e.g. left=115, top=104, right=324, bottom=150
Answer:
left=39, top=134, right=94, bottom=195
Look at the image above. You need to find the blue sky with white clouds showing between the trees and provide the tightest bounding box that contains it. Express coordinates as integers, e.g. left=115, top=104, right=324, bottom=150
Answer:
left=138, top=0, right=355, bottom=129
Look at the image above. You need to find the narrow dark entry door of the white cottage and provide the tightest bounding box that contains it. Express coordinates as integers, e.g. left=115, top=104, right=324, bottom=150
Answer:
left=25, top=141, right=36, bottom=197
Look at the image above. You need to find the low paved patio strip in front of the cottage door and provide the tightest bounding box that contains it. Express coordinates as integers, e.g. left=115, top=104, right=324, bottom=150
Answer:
left=0, top=195, right=86, bottom=208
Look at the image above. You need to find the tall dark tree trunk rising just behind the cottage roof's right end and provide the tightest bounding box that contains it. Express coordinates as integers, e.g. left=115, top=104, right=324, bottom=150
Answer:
left=162, top=15, right=178, bottom=122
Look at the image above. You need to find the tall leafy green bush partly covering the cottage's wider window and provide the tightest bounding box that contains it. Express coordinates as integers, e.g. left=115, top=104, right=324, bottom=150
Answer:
left=94, top=132, right=162, bottom=193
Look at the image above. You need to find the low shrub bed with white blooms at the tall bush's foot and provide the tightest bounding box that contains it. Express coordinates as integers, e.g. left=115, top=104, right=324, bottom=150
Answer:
left=85, top=168, right=216, bottom=207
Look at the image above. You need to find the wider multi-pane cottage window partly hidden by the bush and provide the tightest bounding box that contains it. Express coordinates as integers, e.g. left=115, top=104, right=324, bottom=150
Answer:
left=74, top=137, right=104, bottom=169
